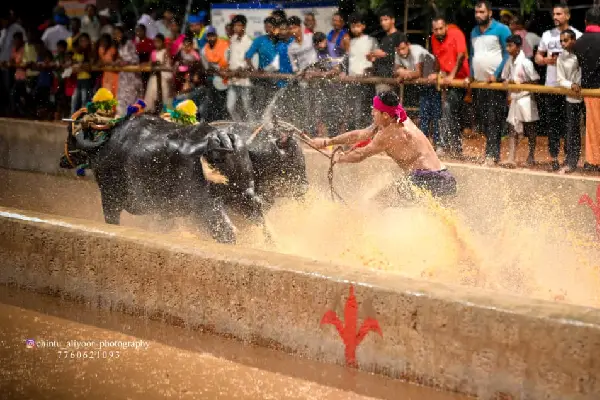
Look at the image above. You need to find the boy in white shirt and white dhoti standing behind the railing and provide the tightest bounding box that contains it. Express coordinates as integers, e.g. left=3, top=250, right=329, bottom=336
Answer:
left=502, top=35, right=540, bottom=168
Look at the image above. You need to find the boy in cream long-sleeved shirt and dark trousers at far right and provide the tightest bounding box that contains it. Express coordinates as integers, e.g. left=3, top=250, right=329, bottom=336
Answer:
left=556, top=29, right=583, bottom=174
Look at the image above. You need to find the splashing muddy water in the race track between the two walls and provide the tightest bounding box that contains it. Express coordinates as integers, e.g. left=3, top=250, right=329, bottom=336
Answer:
left=0, top=170, right=600, bottom=307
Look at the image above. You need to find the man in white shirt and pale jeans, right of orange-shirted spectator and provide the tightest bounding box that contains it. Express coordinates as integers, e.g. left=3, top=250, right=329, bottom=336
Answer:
left=227, top=15, right=252, bottom=121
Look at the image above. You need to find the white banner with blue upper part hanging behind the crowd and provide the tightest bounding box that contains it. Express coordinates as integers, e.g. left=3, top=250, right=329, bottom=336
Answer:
left=210, top=2, right=338, bottom=39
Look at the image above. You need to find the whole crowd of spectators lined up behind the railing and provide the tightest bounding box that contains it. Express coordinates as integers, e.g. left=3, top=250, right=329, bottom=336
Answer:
left=0, top=1, right=600, bottom=173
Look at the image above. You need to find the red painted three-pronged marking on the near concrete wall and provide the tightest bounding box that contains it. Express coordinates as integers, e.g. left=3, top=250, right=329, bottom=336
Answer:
left=321, top=285, right=383, bottom=367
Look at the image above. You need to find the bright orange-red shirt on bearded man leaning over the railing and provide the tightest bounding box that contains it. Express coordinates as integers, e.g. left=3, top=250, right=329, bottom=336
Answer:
left=431, top=25, right=469, bottom=79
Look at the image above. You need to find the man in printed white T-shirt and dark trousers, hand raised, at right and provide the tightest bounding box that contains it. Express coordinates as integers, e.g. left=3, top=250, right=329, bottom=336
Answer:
left=535, top=4, right=581, bottom=171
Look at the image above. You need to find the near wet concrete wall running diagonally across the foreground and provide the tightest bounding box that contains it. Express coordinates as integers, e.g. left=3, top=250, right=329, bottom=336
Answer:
left=0, top=208, right=600, bottom=400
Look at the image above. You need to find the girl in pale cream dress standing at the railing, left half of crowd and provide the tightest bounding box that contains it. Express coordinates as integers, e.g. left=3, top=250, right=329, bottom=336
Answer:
left=145, top=33, right=173, bottom=111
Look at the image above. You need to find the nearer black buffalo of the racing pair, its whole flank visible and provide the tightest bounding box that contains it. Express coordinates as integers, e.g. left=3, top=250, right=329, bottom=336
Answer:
left=62, top=115, right=264, bottom=243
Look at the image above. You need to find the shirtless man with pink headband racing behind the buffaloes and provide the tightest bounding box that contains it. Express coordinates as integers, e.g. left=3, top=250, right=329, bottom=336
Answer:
left=312, top=92, right=456, bottom=197
